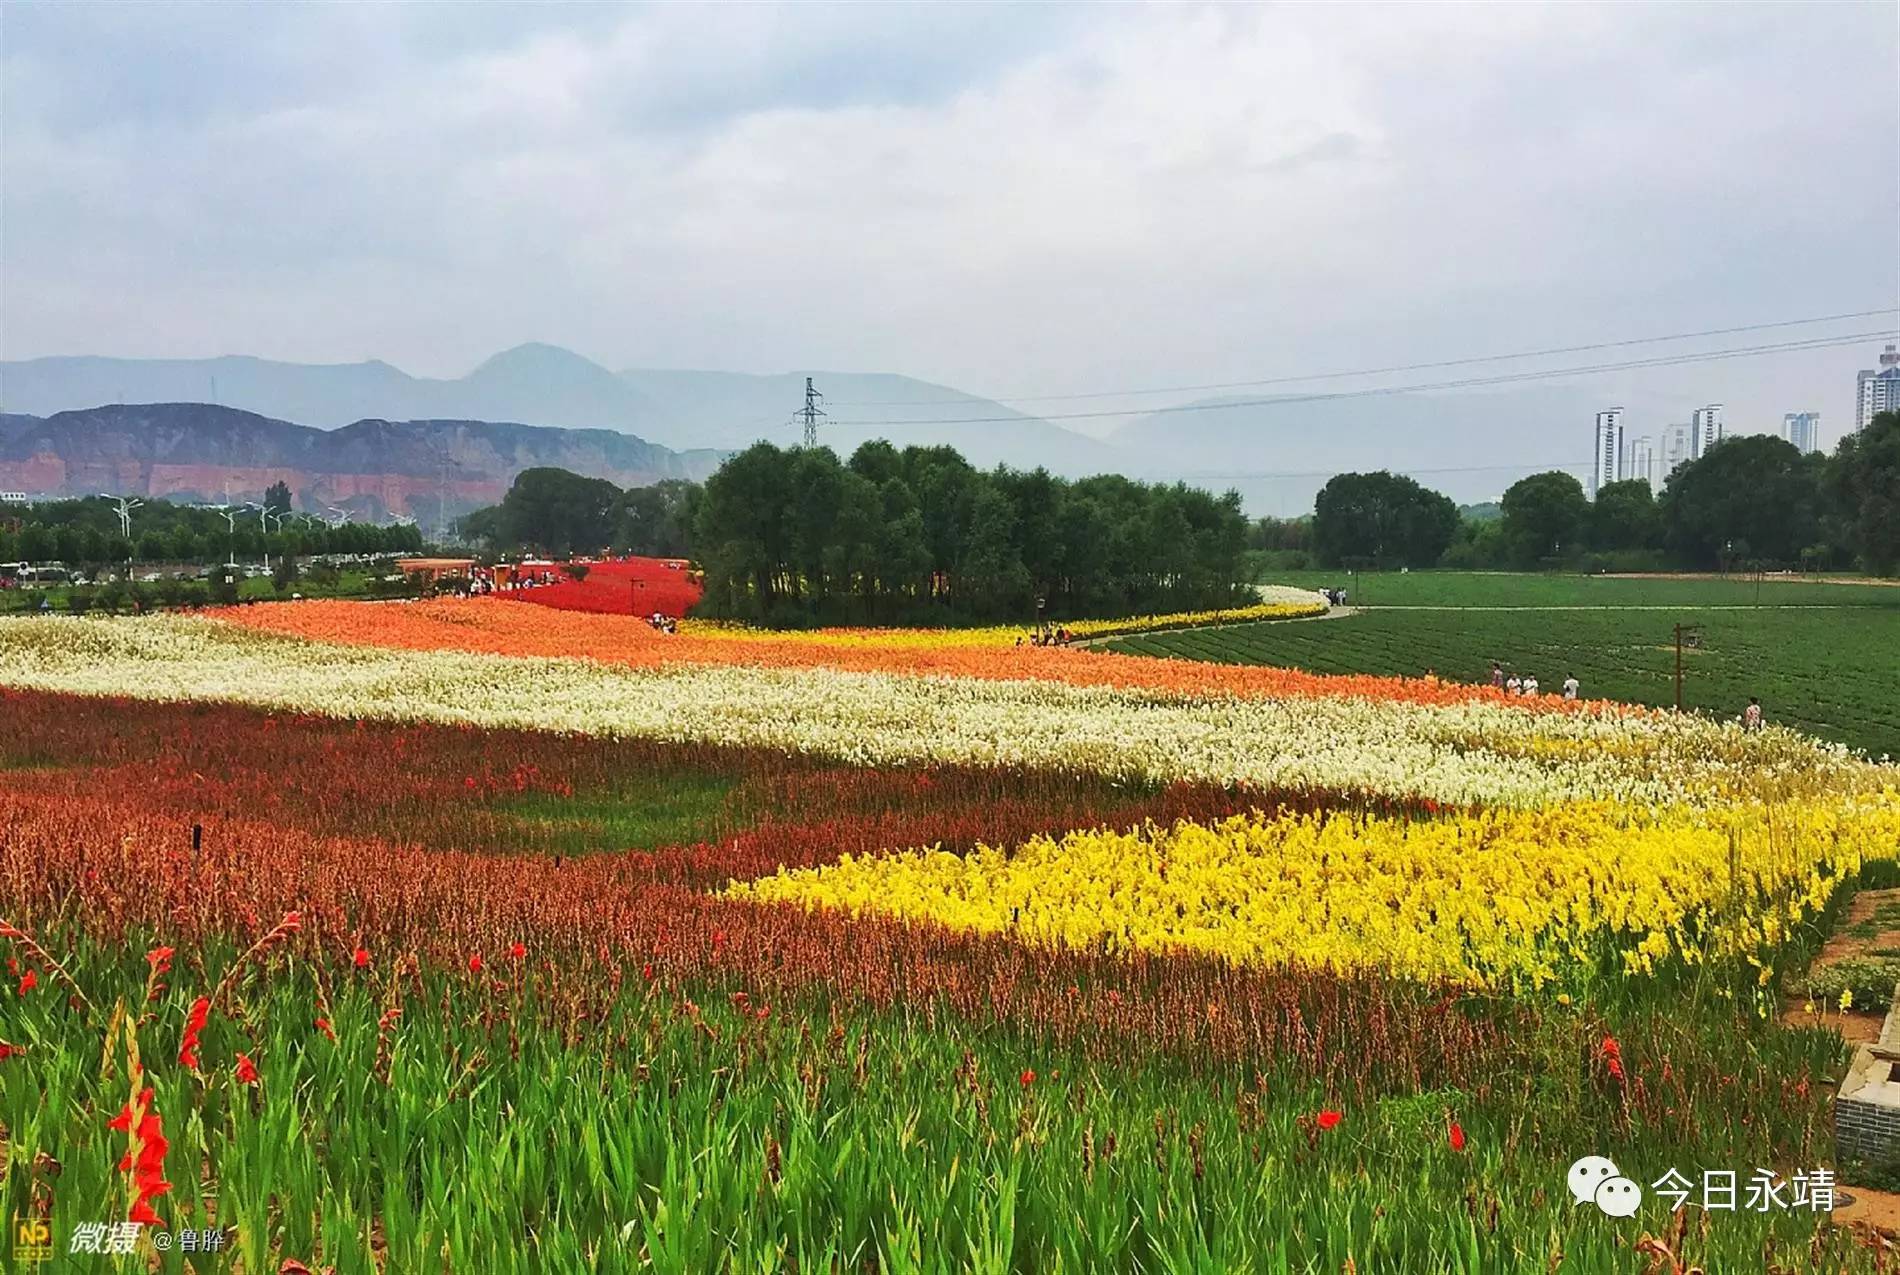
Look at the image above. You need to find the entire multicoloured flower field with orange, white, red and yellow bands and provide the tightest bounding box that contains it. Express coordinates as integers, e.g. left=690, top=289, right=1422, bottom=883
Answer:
left=0, top=604, right=1900, bottom=1271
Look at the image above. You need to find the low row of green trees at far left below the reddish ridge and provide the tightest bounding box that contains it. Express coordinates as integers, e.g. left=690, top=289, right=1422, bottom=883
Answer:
left=0, top=483, right=422, bottom=566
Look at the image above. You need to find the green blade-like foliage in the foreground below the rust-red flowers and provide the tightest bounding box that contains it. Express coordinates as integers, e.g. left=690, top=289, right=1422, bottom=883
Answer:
left=0, top=933, right=1879, bottom=1275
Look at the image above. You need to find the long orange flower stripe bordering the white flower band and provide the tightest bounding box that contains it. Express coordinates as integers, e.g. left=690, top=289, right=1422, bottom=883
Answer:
left=211, top=599, right=1573, bottom=711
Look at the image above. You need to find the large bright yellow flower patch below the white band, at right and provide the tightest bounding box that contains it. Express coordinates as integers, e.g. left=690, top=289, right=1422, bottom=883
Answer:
left=728, top=789, right=1900, bottom=988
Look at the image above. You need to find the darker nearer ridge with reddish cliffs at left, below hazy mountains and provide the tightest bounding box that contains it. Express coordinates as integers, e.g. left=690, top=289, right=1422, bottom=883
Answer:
left=0, top=403, right=724, bottom=526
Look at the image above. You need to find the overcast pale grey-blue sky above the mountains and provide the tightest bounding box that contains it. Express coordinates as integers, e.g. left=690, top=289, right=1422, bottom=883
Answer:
left=0, top=0, right=1900, bottom=448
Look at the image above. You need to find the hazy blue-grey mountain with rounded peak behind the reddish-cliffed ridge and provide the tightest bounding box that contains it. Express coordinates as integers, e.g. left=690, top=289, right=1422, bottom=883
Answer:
left=0, top=344, right=1119, bottom=475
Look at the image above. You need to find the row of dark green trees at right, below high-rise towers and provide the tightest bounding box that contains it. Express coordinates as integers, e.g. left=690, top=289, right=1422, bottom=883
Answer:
left=1276, top=412, right=1900, bottom=574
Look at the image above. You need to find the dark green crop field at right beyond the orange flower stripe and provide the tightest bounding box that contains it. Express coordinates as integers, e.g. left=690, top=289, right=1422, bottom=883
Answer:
left=1110, top=572, right=1900, bottom=754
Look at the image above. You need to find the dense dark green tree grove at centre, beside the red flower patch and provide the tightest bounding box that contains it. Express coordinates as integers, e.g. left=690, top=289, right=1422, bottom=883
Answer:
left=460, top=441, right=1246, bottom=623
